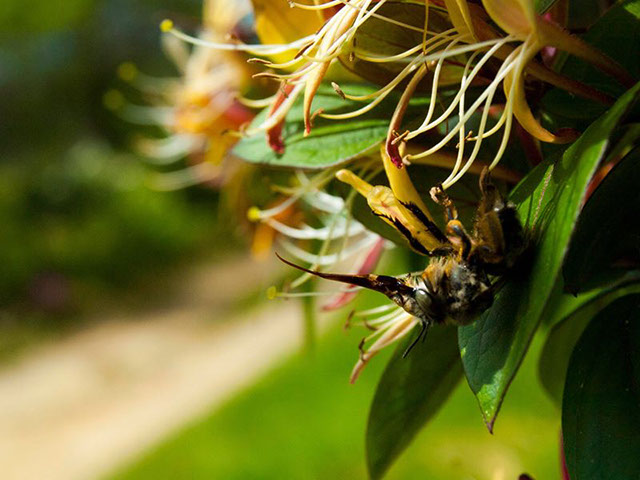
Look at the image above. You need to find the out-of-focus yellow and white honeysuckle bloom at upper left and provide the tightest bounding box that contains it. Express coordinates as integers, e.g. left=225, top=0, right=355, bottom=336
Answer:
left=112, top=0, right=253, bottom=188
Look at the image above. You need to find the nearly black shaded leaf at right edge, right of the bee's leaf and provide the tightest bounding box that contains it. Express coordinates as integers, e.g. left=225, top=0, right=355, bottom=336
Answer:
left=562, top=149, right=640, bottom=294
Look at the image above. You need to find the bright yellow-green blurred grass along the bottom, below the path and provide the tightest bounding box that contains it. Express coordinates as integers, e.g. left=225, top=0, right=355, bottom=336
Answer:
left=109, top=320, right=560, bottom=480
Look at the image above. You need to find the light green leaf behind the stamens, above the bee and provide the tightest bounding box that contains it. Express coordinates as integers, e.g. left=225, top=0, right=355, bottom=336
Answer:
left=233, top=84, right=427, bottom=169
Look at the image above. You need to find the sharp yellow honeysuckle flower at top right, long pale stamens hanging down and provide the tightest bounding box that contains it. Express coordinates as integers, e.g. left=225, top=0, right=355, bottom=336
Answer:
left=396, top=0, right=632, bottom=188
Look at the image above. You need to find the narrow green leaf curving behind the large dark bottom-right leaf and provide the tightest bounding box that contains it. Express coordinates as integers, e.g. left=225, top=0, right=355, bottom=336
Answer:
left=538, top=273, right=640, bottom=406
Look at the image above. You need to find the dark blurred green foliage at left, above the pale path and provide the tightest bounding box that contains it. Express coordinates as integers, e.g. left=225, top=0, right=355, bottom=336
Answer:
left=0, top=0, right=246, bottom=356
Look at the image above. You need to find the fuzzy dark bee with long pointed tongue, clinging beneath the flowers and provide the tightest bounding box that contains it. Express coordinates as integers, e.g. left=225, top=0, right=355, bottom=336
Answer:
left=278, top=168, right=525, bottom=355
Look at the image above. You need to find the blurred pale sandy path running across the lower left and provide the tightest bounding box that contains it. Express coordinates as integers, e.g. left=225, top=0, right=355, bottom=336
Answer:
left=0, top=260, right=302, bottom=480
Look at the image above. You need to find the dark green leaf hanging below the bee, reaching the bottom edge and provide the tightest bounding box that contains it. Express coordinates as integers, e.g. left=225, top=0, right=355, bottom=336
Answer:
left=366, top=326, right=462, bottom=479
